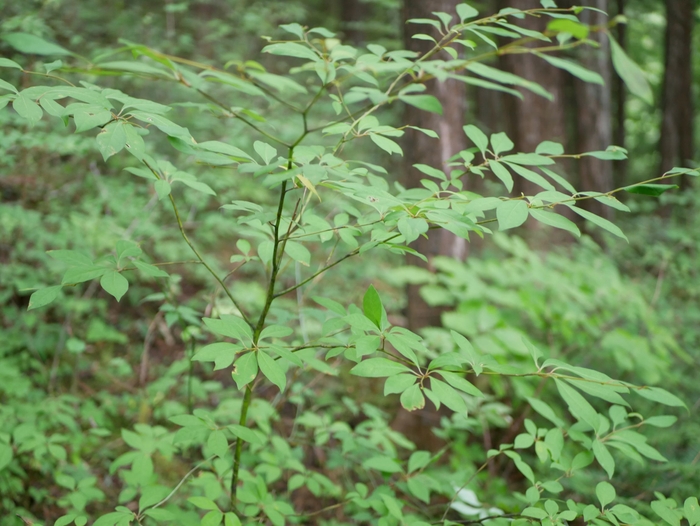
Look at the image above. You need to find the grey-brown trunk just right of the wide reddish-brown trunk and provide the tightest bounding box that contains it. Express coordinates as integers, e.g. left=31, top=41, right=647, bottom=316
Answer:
left=574, top=0, right=614, bottom=219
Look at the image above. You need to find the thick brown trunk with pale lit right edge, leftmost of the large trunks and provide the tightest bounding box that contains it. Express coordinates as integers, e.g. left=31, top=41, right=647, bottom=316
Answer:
left=403, top=0, right=467, bottom=330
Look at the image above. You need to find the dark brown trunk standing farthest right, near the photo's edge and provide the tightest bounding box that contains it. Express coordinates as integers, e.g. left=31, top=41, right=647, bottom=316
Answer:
left=659, top=0, right=693, bottom=186
